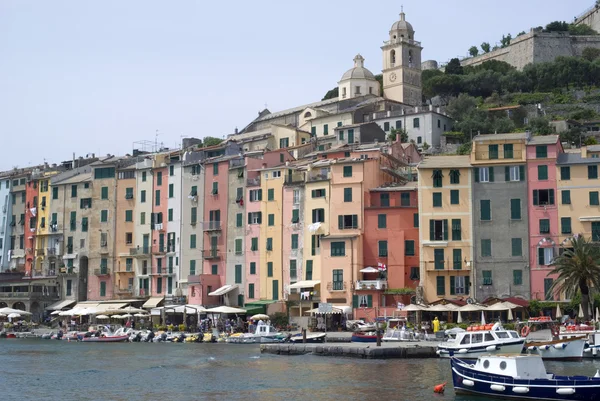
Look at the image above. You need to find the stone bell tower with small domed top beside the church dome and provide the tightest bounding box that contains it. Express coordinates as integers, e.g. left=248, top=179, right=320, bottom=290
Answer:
left=381, top=11, right=423, bottom=106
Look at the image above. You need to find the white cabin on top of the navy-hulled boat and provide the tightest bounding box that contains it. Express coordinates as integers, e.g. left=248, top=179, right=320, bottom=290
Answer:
left=474, top=355, right=552, bottom=380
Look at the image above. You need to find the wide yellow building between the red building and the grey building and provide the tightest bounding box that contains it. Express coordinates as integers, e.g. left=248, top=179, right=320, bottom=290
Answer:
left=418, top=156, right=473, bottom=302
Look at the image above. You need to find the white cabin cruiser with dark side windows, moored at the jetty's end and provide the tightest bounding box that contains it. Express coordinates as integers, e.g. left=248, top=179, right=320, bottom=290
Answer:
left=436, top=323, right=525, bottom=359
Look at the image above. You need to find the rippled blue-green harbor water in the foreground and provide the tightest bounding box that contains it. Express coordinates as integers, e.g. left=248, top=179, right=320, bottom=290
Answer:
left=0, top=339, right=600, bottom=401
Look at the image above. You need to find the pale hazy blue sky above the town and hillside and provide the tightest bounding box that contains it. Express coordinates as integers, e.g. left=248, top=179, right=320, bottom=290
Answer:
left=0, top=0, right=594, bottom=170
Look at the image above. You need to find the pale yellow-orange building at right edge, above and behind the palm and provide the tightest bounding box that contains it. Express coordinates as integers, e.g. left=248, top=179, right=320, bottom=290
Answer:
left=556, top=145, right=600, bottom=242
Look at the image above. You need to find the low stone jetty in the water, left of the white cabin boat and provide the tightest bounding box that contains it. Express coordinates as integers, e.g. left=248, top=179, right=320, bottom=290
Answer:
left=260, top=339, right=439, bottom=359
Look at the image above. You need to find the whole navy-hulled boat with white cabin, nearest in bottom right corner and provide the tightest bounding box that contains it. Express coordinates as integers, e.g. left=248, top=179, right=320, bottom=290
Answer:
left=450, top=355, right=600, bottom=401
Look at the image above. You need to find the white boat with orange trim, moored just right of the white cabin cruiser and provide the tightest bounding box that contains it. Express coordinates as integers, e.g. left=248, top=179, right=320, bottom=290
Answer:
left=521, top=316, right=586, bottom=361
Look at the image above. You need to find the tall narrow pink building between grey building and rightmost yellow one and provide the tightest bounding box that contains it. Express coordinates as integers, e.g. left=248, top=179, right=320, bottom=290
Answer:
left=527, top=135, right=563, bottom=300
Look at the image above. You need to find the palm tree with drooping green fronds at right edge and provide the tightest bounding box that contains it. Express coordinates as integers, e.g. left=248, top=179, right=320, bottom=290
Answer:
left=549, top=235, right=600, bottom=320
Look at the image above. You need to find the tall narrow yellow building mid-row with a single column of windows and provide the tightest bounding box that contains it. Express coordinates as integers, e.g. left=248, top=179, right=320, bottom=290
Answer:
left=259, top=166, right=285, bottom=300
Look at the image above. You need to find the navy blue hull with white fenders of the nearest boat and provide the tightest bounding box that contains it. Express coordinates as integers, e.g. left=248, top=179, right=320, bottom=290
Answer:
left=450, top=358, right=600, bottom=401
